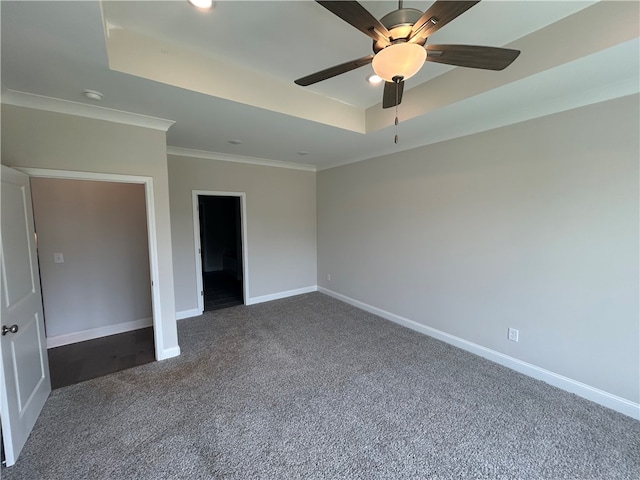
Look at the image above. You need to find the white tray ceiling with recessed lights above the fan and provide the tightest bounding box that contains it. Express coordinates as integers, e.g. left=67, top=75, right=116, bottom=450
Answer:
left=0, top=0, right=640, bottom=168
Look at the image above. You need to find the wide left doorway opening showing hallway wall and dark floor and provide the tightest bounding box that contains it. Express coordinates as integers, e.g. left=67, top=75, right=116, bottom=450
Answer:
left=31, top=177, right=155, bottom=389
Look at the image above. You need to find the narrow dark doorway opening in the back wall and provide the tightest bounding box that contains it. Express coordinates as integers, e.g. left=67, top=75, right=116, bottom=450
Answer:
left=198, top=195, right=244, bottom=312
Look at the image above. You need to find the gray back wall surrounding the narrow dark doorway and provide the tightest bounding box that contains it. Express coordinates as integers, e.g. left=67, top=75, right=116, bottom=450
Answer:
left=169, top=155, right=316, bottom=312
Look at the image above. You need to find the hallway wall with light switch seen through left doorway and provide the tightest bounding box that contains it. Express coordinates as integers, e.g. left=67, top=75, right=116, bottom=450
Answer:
left=31, top=178, right=153, bottom=338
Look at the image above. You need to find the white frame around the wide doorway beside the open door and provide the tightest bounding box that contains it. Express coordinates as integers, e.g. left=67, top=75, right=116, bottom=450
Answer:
left=13, top=167, right=164, bottom=360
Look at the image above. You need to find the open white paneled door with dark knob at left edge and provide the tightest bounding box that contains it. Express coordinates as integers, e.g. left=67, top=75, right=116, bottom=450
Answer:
left=0, top=165, right=51, bottom=466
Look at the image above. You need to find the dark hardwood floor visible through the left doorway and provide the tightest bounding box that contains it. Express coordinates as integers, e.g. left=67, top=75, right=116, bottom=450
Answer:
left=47, top=327, right=155, bottom=389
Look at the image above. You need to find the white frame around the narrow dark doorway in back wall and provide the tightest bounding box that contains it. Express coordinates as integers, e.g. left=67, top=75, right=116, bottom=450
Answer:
left=191, top=190, right=249, bottom=315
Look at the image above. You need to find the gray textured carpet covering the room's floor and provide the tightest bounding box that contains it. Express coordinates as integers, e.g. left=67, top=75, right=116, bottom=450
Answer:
left=2, top=293, right=640, bottom=480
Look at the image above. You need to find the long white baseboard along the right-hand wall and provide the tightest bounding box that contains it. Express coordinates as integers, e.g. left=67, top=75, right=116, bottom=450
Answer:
left=318, top=287, right=640, bottom=420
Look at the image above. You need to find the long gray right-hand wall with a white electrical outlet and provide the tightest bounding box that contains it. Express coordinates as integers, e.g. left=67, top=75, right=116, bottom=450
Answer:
left=317, top=96, right=640, bottom=402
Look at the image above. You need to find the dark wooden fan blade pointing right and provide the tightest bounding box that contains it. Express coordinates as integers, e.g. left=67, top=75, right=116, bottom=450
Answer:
left=425, top=45, right=520, bottom=70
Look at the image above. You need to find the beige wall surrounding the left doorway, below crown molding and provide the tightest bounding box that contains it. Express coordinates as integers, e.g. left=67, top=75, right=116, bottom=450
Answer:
left=2, top=105, right=180, bottom=359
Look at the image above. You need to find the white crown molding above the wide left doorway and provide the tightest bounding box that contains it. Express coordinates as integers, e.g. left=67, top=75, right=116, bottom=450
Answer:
left=1, top=89, right=176, bottom=132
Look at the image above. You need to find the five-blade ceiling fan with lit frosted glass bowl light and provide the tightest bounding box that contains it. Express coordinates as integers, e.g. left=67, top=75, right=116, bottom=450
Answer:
left=295, top=0, right=520, bottom=108
